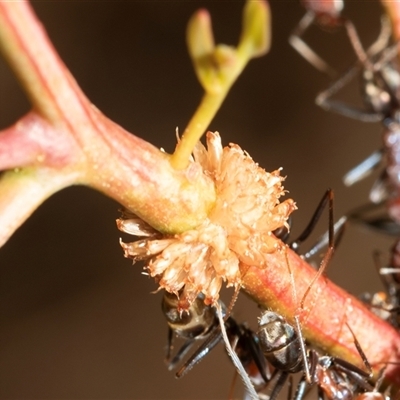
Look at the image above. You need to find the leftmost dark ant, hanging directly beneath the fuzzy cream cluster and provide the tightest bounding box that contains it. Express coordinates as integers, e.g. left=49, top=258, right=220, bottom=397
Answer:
left=162, top=292, right=271, bottom=399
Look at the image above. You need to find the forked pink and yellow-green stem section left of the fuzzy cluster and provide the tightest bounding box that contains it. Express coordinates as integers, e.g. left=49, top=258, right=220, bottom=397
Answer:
left=0, top=2, right=215, bottom=245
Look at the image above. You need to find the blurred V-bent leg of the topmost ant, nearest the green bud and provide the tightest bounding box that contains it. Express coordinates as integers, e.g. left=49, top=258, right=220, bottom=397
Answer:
left=289, top=11, right=336, bottom=77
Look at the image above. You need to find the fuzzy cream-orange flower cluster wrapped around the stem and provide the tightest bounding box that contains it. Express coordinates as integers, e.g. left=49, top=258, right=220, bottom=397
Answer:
left=117, top=132, right=296, bottom=310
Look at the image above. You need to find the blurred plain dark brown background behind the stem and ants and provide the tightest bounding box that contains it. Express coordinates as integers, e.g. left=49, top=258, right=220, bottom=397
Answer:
left=0, top=0, right=391, bottom=399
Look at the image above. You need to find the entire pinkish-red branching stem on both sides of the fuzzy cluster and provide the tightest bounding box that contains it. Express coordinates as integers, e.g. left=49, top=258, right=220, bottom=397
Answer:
left=0, top=2, right=400, bottom=383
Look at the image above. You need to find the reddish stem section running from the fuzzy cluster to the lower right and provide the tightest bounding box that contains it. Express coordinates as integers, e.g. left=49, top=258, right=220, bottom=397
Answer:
left=244, top=249, right=400, bottom=385
